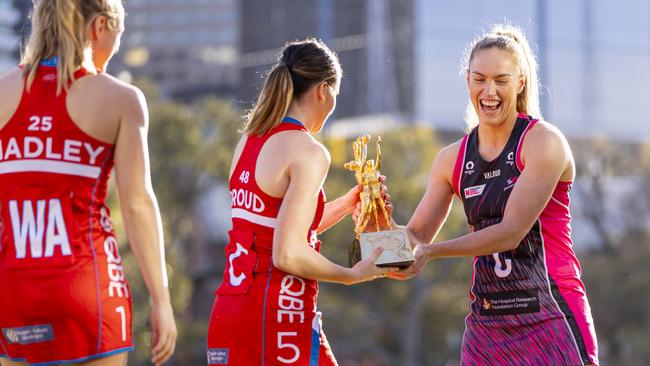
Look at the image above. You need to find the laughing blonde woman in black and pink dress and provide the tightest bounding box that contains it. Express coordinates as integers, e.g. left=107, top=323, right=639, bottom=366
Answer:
left=390, top=24, right=598, bottom=365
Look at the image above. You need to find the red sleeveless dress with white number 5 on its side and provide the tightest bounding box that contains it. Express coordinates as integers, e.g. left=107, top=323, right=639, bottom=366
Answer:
left=207, top=117, right=336, bottom=366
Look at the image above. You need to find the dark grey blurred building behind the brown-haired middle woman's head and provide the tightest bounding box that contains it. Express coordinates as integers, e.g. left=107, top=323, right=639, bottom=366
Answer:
left=239, top=0, right=415, bottom=120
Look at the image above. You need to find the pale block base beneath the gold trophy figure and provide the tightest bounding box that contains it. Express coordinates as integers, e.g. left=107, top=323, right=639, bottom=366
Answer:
left=359, top=229, right=415, bottom=268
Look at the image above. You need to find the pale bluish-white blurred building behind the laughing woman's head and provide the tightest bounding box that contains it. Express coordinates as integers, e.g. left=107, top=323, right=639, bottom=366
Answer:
left=415, top=0, right=650, bottom=141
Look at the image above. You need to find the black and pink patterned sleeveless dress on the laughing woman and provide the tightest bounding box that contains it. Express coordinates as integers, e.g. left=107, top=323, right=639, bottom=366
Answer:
left=454, top=114, right=598, bottom=366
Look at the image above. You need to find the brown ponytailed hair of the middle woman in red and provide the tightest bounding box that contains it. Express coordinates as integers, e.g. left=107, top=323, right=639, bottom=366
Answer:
left=242, top=38, right=342, bottom=135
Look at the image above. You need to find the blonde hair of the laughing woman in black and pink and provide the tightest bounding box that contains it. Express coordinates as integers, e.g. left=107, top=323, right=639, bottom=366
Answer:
left=463, top=23, right=543, bottom=130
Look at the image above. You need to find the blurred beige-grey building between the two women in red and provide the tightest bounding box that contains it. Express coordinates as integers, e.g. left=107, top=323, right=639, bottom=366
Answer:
left=110, top=0, right=239, bottom=99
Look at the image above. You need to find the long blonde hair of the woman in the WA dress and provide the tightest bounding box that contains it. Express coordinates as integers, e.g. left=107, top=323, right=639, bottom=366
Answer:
left=21, top=0, right=123, bottom=94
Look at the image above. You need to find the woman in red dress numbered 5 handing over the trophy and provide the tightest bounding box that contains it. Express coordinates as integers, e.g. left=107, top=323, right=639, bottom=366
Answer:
left=207, top=39, right=394, bottom=366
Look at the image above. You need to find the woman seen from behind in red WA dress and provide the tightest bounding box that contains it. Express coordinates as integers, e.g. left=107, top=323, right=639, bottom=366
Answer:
left=0, top=0, right=176, bottom=366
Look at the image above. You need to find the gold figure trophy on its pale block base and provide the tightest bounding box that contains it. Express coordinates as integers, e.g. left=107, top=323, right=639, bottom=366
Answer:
left=344, top=135, right=414, bottom=268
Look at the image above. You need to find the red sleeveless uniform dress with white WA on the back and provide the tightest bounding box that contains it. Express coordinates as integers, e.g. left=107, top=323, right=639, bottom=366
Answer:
left=0, top=65, right=132, bottom=365
